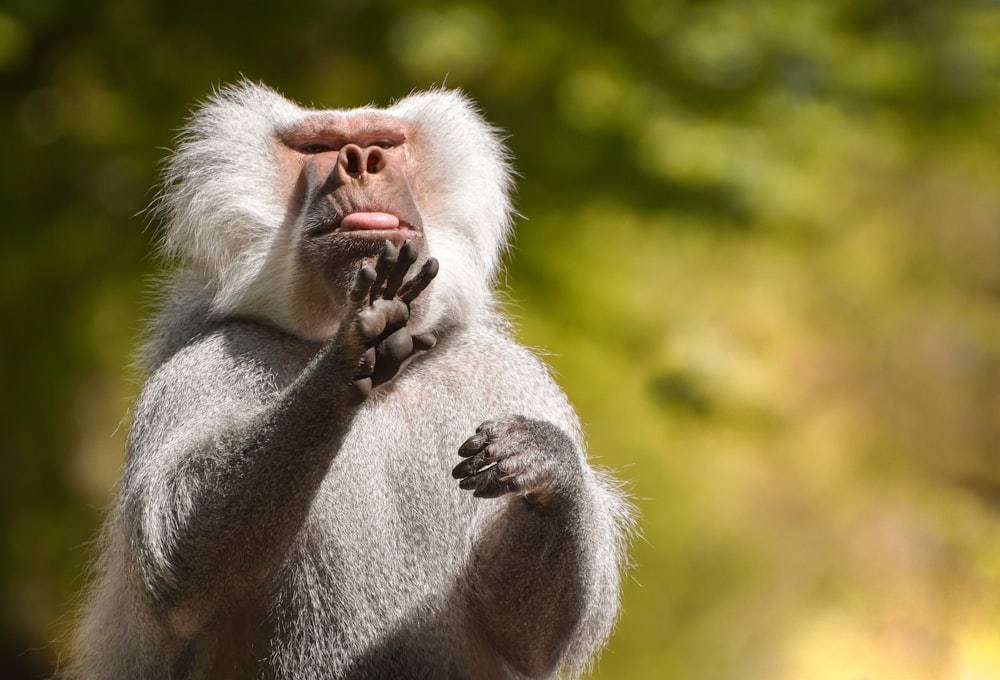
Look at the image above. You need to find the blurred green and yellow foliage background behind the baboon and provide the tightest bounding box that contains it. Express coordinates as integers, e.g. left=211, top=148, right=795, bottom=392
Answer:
left=0, top=0, right=1000, bottom=680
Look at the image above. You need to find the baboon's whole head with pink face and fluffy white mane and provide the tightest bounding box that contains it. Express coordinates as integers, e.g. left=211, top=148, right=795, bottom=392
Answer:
left=154, top=82, right=511, bottom=339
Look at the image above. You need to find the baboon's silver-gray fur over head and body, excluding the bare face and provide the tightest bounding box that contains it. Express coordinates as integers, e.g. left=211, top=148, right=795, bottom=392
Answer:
left=66, top=83, right=630, bottom=680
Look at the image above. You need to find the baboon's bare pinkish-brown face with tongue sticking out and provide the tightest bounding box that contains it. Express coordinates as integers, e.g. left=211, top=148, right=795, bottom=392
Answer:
left=278, top=112, right=426, bottom=325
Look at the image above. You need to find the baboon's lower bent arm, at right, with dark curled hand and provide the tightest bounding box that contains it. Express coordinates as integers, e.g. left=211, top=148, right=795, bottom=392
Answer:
left=453, top=406, right=628, bottom=677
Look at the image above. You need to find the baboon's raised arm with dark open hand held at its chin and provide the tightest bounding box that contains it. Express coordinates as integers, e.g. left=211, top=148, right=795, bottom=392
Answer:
left=119, top=249, right=436, bottom=637
